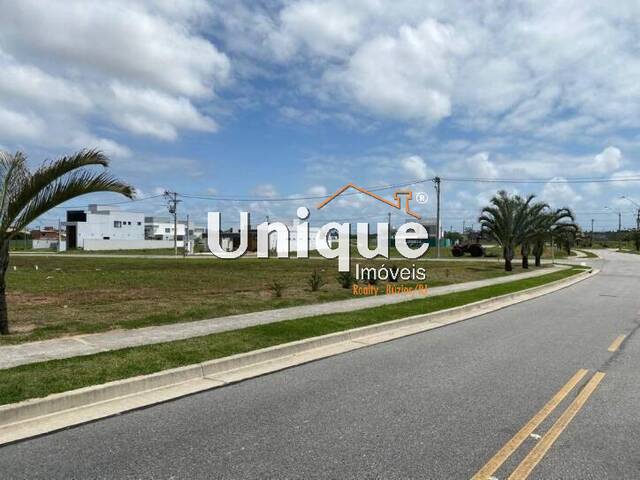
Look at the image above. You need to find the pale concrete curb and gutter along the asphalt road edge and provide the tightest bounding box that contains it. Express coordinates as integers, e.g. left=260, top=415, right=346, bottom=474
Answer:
left=0, top=270, right=599, bottom=445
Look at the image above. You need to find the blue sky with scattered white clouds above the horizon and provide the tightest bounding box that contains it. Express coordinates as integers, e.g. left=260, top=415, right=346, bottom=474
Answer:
left=0, top=0, right=640, bottom=230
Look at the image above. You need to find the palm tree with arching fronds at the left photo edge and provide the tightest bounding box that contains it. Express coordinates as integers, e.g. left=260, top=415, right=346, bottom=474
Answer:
left=0, top=150, right=134, bottom=335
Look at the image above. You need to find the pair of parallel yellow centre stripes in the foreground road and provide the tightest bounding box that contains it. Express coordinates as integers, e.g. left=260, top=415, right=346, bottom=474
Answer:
left=472, top=369, right=605, bottom=480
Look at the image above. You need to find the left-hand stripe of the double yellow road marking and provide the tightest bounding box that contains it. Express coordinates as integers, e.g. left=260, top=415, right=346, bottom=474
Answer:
left=471, top=368, right=588, bottom=480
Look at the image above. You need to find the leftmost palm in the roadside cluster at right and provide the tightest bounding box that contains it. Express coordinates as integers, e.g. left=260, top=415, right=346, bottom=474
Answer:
left=478, top=190, right=534, bottom=272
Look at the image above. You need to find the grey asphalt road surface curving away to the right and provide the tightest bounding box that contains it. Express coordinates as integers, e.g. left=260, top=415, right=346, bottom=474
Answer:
left=0, top=249, right=640, bottom=480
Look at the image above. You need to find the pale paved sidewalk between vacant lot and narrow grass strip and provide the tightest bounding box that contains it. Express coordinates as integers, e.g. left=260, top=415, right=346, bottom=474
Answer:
left=0, top=266, right=568, bottom=369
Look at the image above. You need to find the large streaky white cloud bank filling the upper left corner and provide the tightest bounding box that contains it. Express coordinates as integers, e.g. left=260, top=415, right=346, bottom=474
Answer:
left=0, top=0, right=231, bottom=157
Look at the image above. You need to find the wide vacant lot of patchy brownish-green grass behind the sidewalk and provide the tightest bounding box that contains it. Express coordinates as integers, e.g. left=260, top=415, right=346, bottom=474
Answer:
left=0, top=255, right=540, bottom=344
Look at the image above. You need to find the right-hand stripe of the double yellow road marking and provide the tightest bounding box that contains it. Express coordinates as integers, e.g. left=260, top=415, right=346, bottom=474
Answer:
left=508, top=372, right=605, bottom=480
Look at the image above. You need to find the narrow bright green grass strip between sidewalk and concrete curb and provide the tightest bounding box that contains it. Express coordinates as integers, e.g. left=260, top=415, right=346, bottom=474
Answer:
left=0, top=267, right=584, bottom=405
